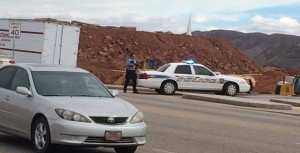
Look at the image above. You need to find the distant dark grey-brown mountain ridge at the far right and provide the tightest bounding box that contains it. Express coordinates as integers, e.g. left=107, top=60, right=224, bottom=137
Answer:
left=193, top=30, right=300, bottom=70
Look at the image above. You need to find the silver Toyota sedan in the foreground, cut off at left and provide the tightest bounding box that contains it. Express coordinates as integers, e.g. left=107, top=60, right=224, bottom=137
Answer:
left=0, top=64, right=146, bottom=153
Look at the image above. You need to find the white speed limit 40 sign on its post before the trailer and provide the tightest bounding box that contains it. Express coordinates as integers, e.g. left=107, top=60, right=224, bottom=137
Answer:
left=9, top=21, right=21, bottom=58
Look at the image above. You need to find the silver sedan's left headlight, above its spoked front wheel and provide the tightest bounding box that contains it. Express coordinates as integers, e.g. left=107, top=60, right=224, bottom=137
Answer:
left=55, top=109, right=91, bottom=123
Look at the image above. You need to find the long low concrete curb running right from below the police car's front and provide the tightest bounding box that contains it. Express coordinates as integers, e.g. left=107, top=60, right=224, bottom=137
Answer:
left=182, top=93, right=292, bottom=110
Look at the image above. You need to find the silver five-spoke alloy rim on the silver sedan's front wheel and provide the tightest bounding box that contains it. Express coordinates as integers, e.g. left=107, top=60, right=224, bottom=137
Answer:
left=35, top=123, right=47, bottom=149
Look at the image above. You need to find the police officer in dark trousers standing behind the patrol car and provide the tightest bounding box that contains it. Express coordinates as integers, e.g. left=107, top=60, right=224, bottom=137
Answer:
left=123, top=53, right=139, bottom=94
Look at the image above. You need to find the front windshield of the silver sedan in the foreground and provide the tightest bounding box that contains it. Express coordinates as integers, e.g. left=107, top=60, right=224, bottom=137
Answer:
left=32, top=71, right=112, bottom=97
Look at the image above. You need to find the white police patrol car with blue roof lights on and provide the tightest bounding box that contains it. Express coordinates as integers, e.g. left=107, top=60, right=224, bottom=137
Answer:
left=137, top=61, right=250, bottom=96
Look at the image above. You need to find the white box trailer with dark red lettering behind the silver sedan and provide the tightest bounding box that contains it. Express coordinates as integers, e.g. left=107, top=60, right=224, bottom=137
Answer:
left=0, top=19, right=80, bottom=66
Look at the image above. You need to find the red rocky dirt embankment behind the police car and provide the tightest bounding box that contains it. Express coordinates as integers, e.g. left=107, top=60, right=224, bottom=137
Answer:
left=78, top=25, right=261, bottom=83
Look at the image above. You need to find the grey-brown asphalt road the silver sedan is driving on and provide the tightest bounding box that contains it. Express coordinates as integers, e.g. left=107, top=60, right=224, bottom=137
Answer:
left=0, top=92, right=300, bottom=153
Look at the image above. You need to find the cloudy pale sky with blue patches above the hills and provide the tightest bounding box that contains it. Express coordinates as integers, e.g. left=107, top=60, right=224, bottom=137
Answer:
left=0, top=0, right=300, bottom=36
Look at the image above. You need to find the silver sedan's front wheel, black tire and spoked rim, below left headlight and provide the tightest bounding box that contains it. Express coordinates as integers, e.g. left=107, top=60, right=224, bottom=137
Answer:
left=31, top=117, right=52, bottom=153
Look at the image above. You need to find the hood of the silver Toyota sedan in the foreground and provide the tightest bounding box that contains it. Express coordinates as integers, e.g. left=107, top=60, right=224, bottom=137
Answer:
left=45, top=97, right=138, bottom=117
